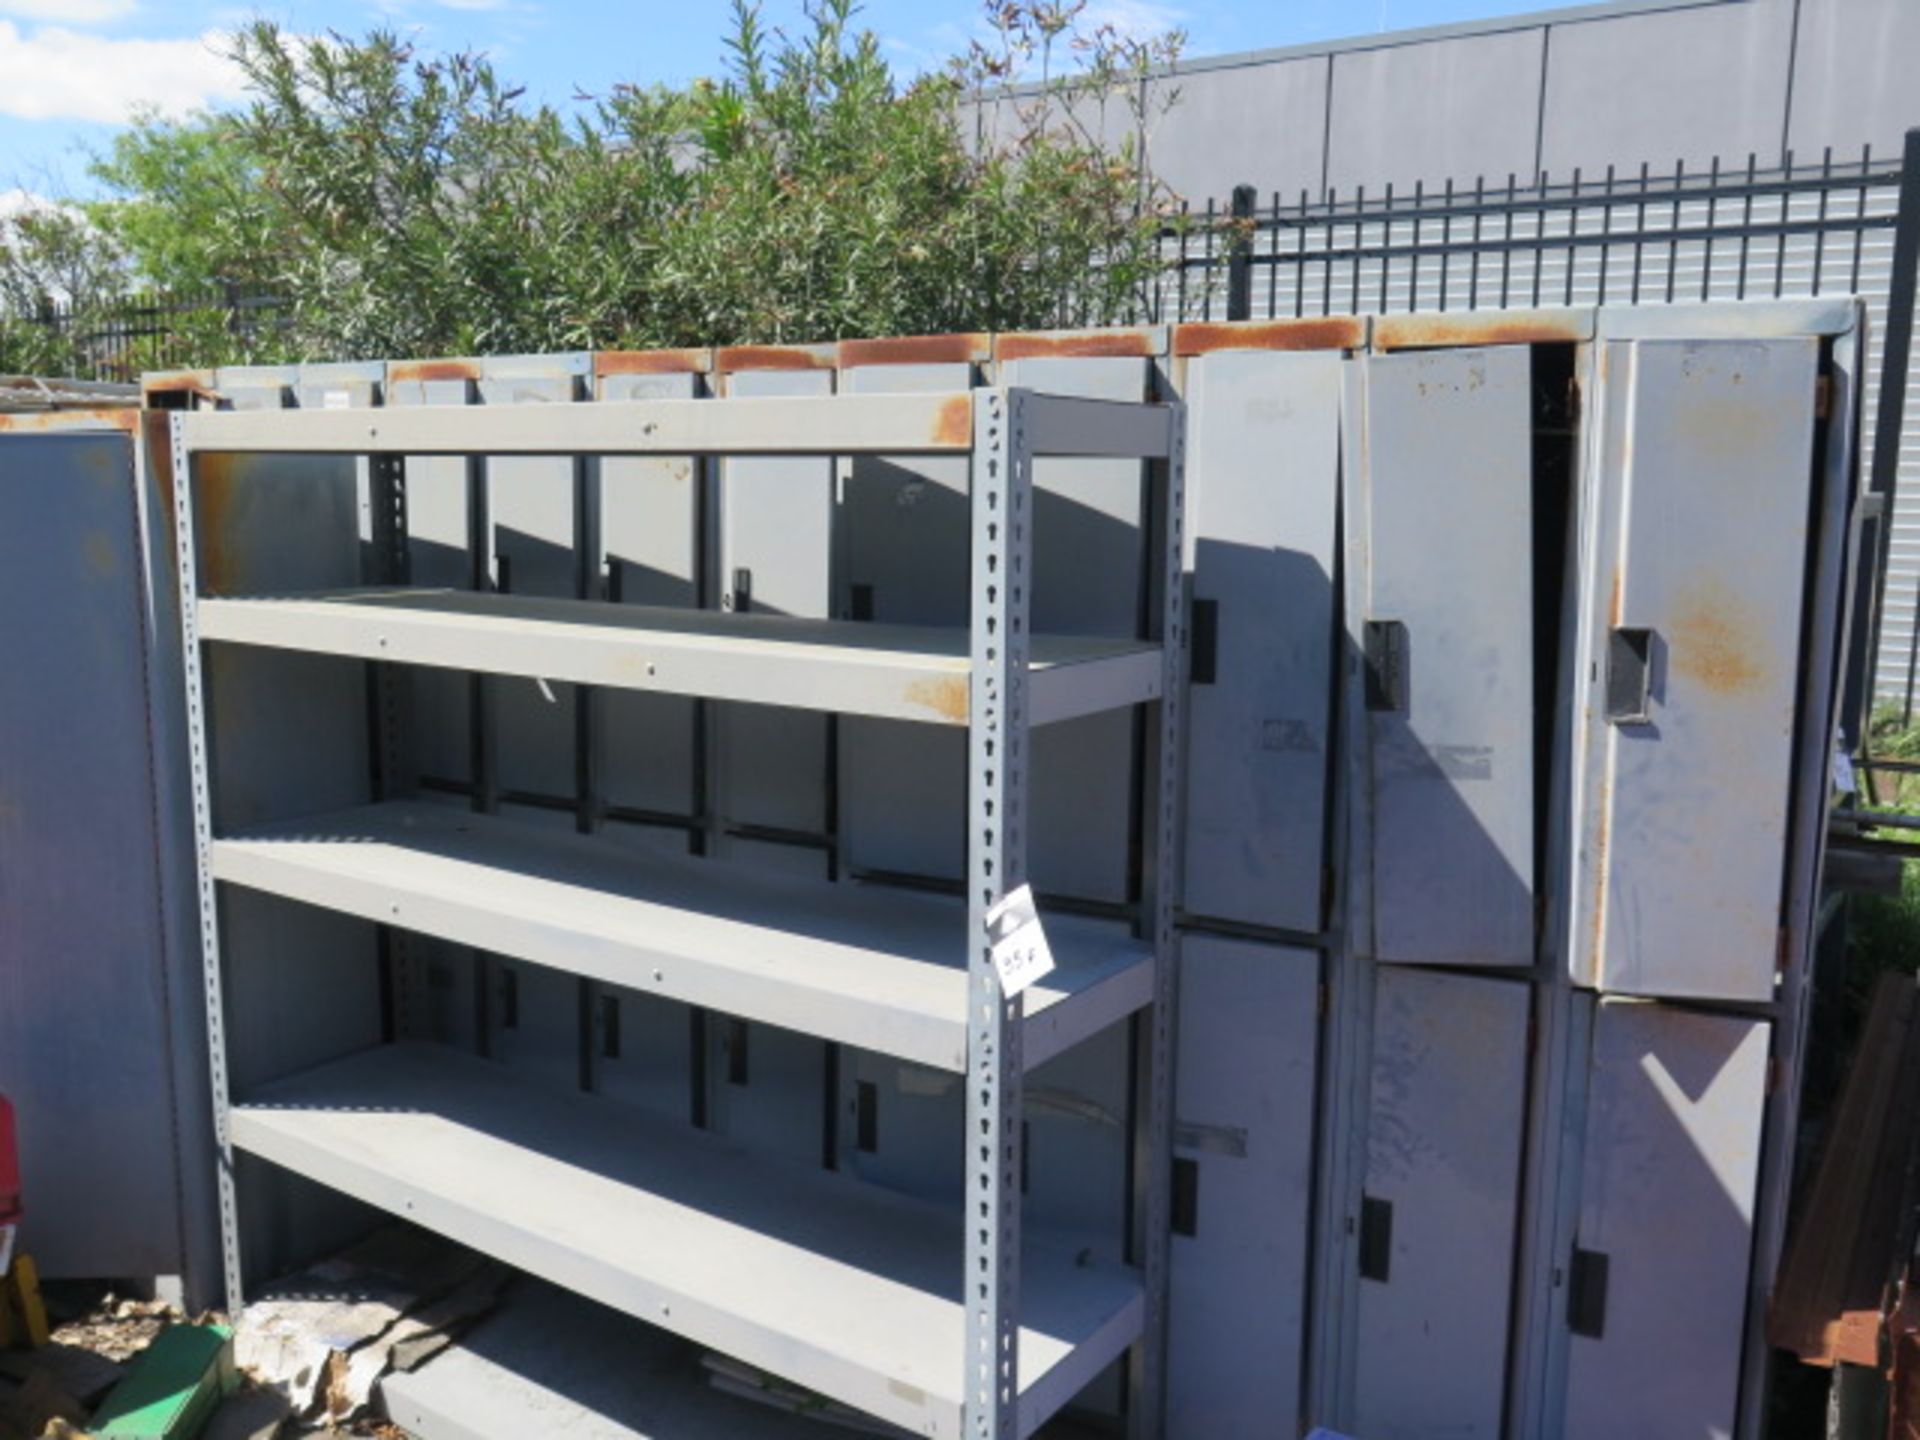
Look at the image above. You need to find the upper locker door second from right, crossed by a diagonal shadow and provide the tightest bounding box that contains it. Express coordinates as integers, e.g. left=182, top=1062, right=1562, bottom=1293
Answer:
left=1350, top=346, right=1534, bottom=966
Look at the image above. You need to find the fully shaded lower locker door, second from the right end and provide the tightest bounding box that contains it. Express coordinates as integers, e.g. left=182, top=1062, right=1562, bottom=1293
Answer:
left=1352, top=966, right=1530, bottom=1440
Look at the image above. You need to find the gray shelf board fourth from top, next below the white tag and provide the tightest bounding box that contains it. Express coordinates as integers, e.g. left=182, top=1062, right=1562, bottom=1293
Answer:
left=230, top=1044, right=1144, bottom=1436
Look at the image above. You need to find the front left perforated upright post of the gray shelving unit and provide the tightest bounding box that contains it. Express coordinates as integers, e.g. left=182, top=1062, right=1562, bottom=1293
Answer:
left=167, top=415, right=242, bottom=1313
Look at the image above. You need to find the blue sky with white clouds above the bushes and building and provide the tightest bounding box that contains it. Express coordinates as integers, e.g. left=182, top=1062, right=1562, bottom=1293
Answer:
left=0, top=0, right=1549, bottom=207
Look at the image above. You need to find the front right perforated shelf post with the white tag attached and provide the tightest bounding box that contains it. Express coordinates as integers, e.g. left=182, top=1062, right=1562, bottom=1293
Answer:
left=960, top=388, right=1033, bottom=1440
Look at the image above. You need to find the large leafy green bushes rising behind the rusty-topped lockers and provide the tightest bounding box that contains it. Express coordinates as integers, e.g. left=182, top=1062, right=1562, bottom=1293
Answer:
left=11, top=0, right=1179, bottom=361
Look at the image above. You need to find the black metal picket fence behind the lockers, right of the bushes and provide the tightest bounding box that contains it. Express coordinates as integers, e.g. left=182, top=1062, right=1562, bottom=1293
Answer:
left=1142, top=131, right=1920, bottom=720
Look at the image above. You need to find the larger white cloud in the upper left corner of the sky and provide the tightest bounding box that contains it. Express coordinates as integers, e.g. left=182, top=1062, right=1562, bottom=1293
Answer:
left=0, top=19, right=244, bottom=125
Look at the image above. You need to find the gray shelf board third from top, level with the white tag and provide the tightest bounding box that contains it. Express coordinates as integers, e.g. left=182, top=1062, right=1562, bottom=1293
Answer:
left=211, top=801, right=1154, bottom=1071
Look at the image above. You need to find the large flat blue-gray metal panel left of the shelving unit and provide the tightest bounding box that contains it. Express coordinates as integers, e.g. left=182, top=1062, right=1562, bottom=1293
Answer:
left=0, top=430, right=192, bottom=1277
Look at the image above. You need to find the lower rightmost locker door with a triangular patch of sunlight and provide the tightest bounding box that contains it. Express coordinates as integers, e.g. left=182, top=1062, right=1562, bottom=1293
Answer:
left=1565, top=998, right=1768, bottom=1440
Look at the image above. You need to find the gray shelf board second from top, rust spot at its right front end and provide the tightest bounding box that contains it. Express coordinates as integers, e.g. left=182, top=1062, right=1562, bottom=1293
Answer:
left=198, top=588, right=1162, bottom=726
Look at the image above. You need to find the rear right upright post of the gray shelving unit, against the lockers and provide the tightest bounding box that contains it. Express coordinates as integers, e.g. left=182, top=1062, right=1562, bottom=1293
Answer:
left=1127, top=403, right=1187, bottom=1440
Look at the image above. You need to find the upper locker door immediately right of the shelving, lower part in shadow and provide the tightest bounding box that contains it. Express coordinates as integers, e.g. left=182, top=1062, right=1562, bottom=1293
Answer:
left=1185, top=349, right=1342, bottom=933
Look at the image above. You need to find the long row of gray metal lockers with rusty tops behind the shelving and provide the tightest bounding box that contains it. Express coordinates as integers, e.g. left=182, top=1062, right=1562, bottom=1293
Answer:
left=3, top=295, right=1857, bottom=1440
